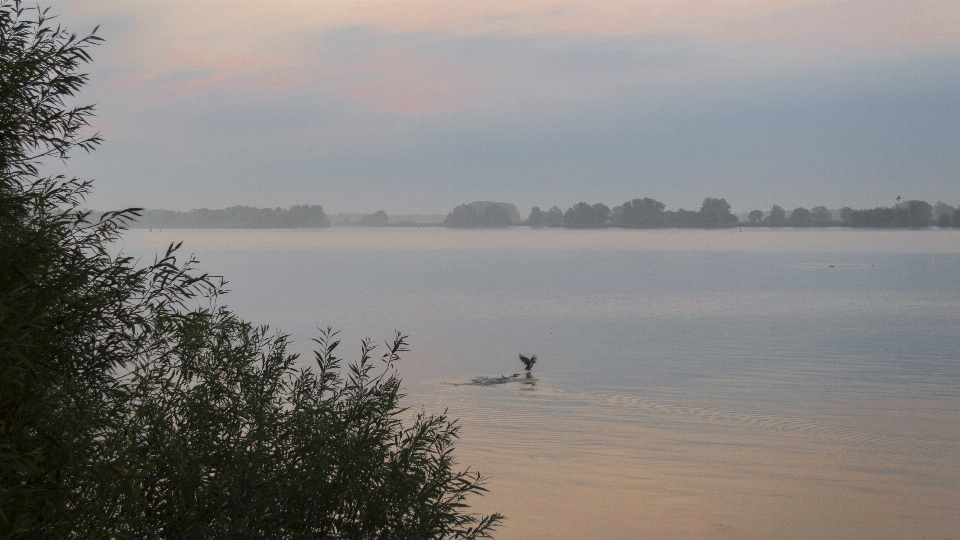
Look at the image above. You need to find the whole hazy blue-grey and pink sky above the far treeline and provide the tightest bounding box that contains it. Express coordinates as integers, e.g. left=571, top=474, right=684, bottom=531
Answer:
left=45, top=0, right=960, bottom=214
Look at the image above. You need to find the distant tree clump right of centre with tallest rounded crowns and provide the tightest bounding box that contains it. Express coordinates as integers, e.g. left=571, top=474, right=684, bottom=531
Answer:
left=526, top=198, right=737, bottom=229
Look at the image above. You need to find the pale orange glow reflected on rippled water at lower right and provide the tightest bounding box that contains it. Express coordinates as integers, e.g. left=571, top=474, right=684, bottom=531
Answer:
left=429, top=383, right=960, bottom=540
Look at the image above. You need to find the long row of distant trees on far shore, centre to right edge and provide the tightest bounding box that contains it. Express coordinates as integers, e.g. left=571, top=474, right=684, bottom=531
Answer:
left=443, top=197, right=960, bottom=229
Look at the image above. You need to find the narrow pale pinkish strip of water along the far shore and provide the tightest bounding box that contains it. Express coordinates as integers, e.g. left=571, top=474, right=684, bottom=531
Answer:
left=127, top=227, right=960, bottom=253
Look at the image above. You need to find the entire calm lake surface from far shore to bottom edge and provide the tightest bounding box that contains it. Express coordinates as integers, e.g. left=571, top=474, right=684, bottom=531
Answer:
left=125, top=228, right=960, bottom=539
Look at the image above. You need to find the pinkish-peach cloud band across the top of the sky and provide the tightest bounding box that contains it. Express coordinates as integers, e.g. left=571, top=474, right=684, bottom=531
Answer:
left=60, top=0, right=960, bottom=113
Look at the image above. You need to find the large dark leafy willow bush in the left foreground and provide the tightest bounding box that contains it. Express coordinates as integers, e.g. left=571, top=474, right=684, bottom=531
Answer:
left=0, top=1, right=501, bottom=539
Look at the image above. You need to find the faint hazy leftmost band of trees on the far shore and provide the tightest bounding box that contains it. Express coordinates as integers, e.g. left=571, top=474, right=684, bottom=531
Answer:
left=134, top=205, right=330, bottom=229
